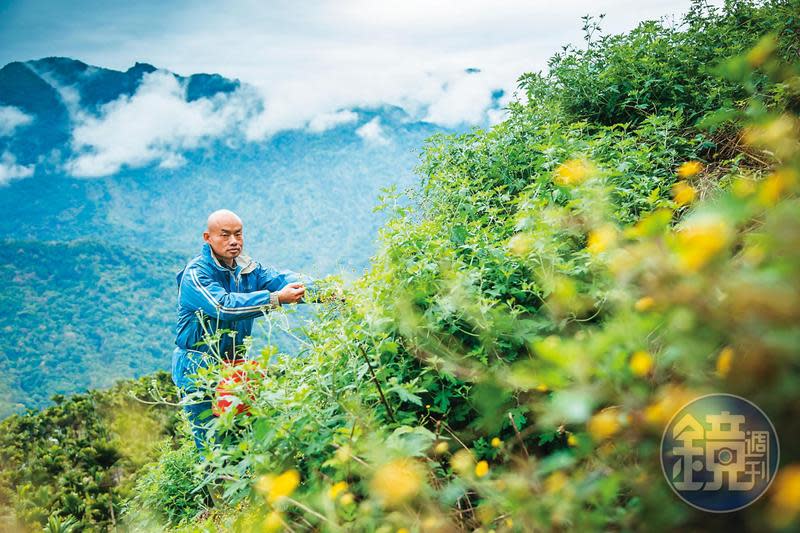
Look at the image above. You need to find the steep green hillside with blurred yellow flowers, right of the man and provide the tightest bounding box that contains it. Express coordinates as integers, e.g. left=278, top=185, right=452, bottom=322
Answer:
left=1, top=0, right=800, bottom=532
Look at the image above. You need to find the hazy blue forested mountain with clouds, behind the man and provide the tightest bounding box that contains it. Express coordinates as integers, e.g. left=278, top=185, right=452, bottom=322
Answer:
left=0, top=58, right=460, bottom=416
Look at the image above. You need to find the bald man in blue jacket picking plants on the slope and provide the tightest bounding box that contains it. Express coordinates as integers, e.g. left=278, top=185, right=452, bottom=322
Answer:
left=172, top=209, right=311, bottom=449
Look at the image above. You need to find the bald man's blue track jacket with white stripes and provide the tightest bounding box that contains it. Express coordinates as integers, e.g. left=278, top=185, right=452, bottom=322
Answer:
left=172, top=243, right=313, bottom=391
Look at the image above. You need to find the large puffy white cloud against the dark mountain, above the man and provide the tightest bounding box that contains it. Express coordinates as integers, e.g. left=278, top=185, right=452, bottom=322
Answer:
left=67, top=71, right=258, bottom=177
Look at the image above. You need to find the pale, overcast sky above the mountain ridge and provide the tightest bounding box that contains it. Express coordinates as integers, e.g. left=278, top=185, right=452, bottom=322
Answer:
left=0, top=0, right=712, bottom=139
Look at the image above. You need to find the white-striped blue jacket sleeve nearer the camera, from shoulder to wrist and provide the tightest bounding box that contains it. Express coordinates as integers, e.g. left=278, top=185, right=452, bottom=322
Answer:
left=181, top=267, right=278, bottom=321
